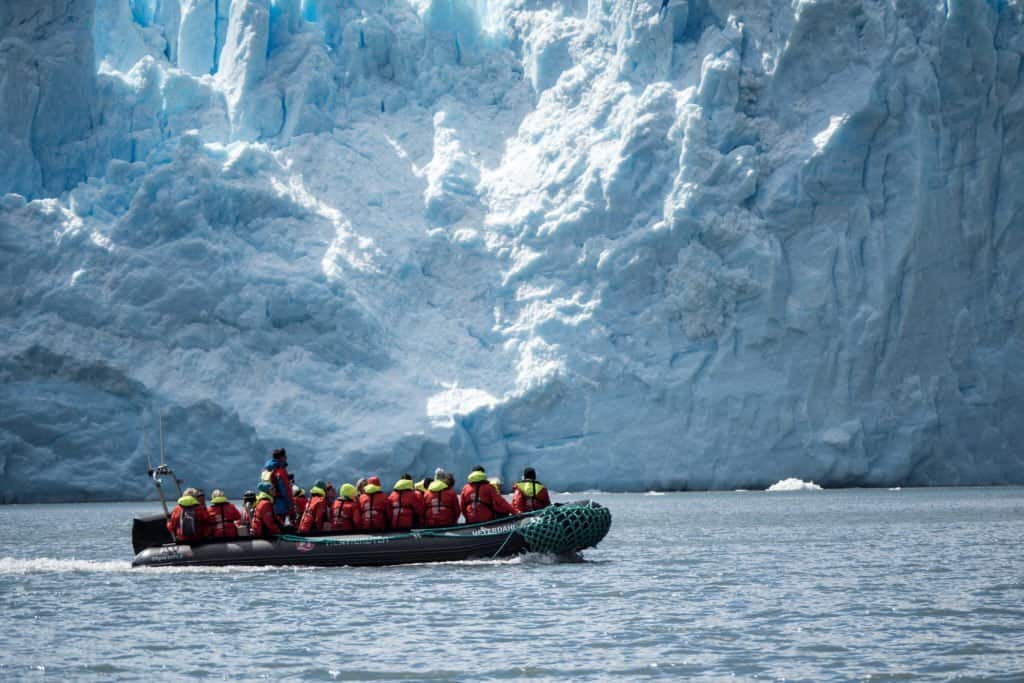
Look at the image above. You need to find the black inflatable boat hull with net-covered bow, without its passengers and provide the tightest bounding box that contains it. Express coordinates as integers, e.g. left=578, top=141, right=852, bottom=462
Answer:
left=132, top=501, right=611, bottom=567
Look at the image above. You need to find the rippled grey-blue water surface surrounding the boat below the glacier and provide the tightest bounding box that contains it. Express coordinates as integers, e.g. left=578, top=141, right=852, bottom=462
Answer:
left=0, top=488, right=1024, bottom=681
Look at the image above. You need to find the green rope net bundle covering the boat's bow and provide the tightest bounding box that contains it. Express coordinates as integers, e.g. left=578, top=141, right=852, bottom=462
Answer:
left=518, top=501, right=611, bottom=553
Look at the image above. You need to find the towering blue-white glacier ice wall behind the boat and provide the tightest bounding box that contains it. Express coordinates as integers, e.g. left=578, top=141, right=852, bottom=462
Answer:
left=0, top=0, right=1024, bottom=502
